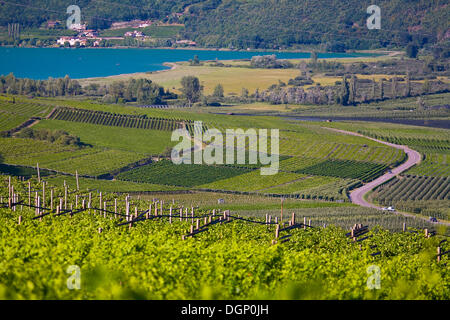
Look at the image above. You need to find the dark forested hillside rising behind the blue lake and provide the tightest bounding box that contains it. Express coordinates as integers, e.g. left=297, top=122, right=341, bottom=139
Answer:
left=0, top=0, right=450, bottom=51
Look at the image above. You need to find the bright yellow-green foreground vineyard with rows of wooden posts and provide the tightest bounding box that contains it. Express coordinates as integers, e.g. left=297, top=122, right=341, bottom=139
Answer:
left=0, top=176, right=450, bottom=300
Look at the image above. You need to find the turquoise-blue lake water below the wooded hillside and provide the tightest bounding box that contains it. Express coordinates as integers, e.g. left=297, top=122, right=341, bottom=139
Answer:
left=0, top=47, right=374, bottom=79
